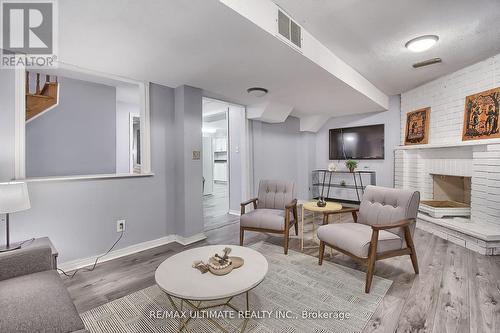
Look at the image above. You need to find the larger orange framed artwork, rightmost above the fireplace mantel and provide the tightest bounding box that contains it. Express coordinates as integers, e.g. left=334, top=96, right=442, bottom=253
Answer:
left=462, top=87, right=500, bottom=141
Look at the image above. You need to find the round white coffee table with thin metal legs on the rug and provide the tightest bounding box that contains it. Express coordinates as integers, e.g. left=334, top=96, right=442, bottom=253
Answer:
left=155, top=245, right=268, bottom=332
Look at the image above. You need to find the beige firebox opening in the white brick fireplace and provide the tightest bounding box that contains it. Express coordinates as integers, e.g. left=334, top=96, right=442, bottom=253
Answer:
left=420, top=174, right=471, bottom=218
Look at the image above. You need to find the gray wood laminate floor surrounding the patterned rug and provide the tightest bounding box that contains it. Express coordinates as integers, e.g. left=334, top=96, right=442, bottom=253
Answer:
left=63, top=215, right=500, bottom=333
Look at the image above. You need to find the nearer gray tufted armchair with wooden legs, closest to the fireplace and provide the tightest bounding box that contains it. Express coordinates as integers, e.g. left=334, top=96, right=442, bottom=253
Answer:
left=318, top=186, right=420, bottom=293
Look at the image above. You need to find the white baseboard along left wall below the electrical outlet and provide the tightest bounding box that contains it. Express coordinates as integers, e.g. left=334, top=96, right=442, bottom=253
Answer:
left=57, top=233, right=207, bottom=272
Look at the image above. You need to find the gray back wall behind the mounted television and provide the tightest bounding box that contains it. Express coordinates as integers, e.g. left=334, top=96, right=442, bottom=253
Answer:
left=252, top=96, right=400, bottom=199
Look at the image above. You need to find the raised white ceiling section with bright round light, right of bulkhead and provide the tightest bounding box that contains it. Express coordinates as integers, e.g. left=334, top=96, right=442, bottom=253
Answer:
left=274, top=0, right=500, bottom=95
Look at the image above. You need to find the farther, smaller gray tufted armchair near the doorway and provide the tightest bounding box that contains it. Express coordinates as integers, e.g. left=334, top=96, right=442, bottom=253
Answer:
left=240, top=180, right=298, bottom=254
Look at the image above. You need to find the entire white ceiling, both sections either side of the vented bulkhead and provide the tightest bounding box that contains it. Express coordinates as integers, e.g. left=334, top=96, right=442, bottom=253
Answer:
left=59, top=0, right=500, bottom=117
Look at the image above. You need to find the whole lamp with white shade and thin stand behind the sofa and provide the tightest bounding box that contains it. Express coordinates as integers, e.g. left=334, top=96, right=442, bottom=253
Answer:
left=0, top=182, right=31, bottom=252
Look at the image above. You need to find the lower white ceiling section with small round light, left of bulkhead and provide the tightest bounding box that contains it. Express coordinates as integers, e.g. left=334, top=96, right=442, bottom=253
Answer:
left=59, top=0, right=381, bottom=116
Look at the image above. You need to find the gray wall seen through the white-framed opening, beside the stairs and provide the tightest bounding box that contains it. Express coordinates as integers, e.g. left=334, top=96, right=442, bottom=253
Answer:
left=26, top=77, right=116, bottom=177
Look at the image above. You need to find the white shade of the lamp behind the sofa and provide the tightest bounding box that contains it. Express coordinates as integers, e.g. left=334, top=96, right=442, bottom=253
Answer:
left=0, top=182, right=31, bottom=214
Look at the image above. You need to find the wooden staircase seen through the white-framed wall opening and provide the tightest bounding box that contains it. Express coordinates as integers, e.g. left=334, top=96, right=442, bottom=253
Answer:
left=26, top=72, right=59, bottom=122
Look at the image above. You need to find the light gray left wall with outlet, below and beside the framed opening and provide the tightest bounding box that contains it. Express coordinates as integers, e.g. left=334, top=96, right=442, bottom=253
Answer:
left=0, top=82, right=180, bottom=262
